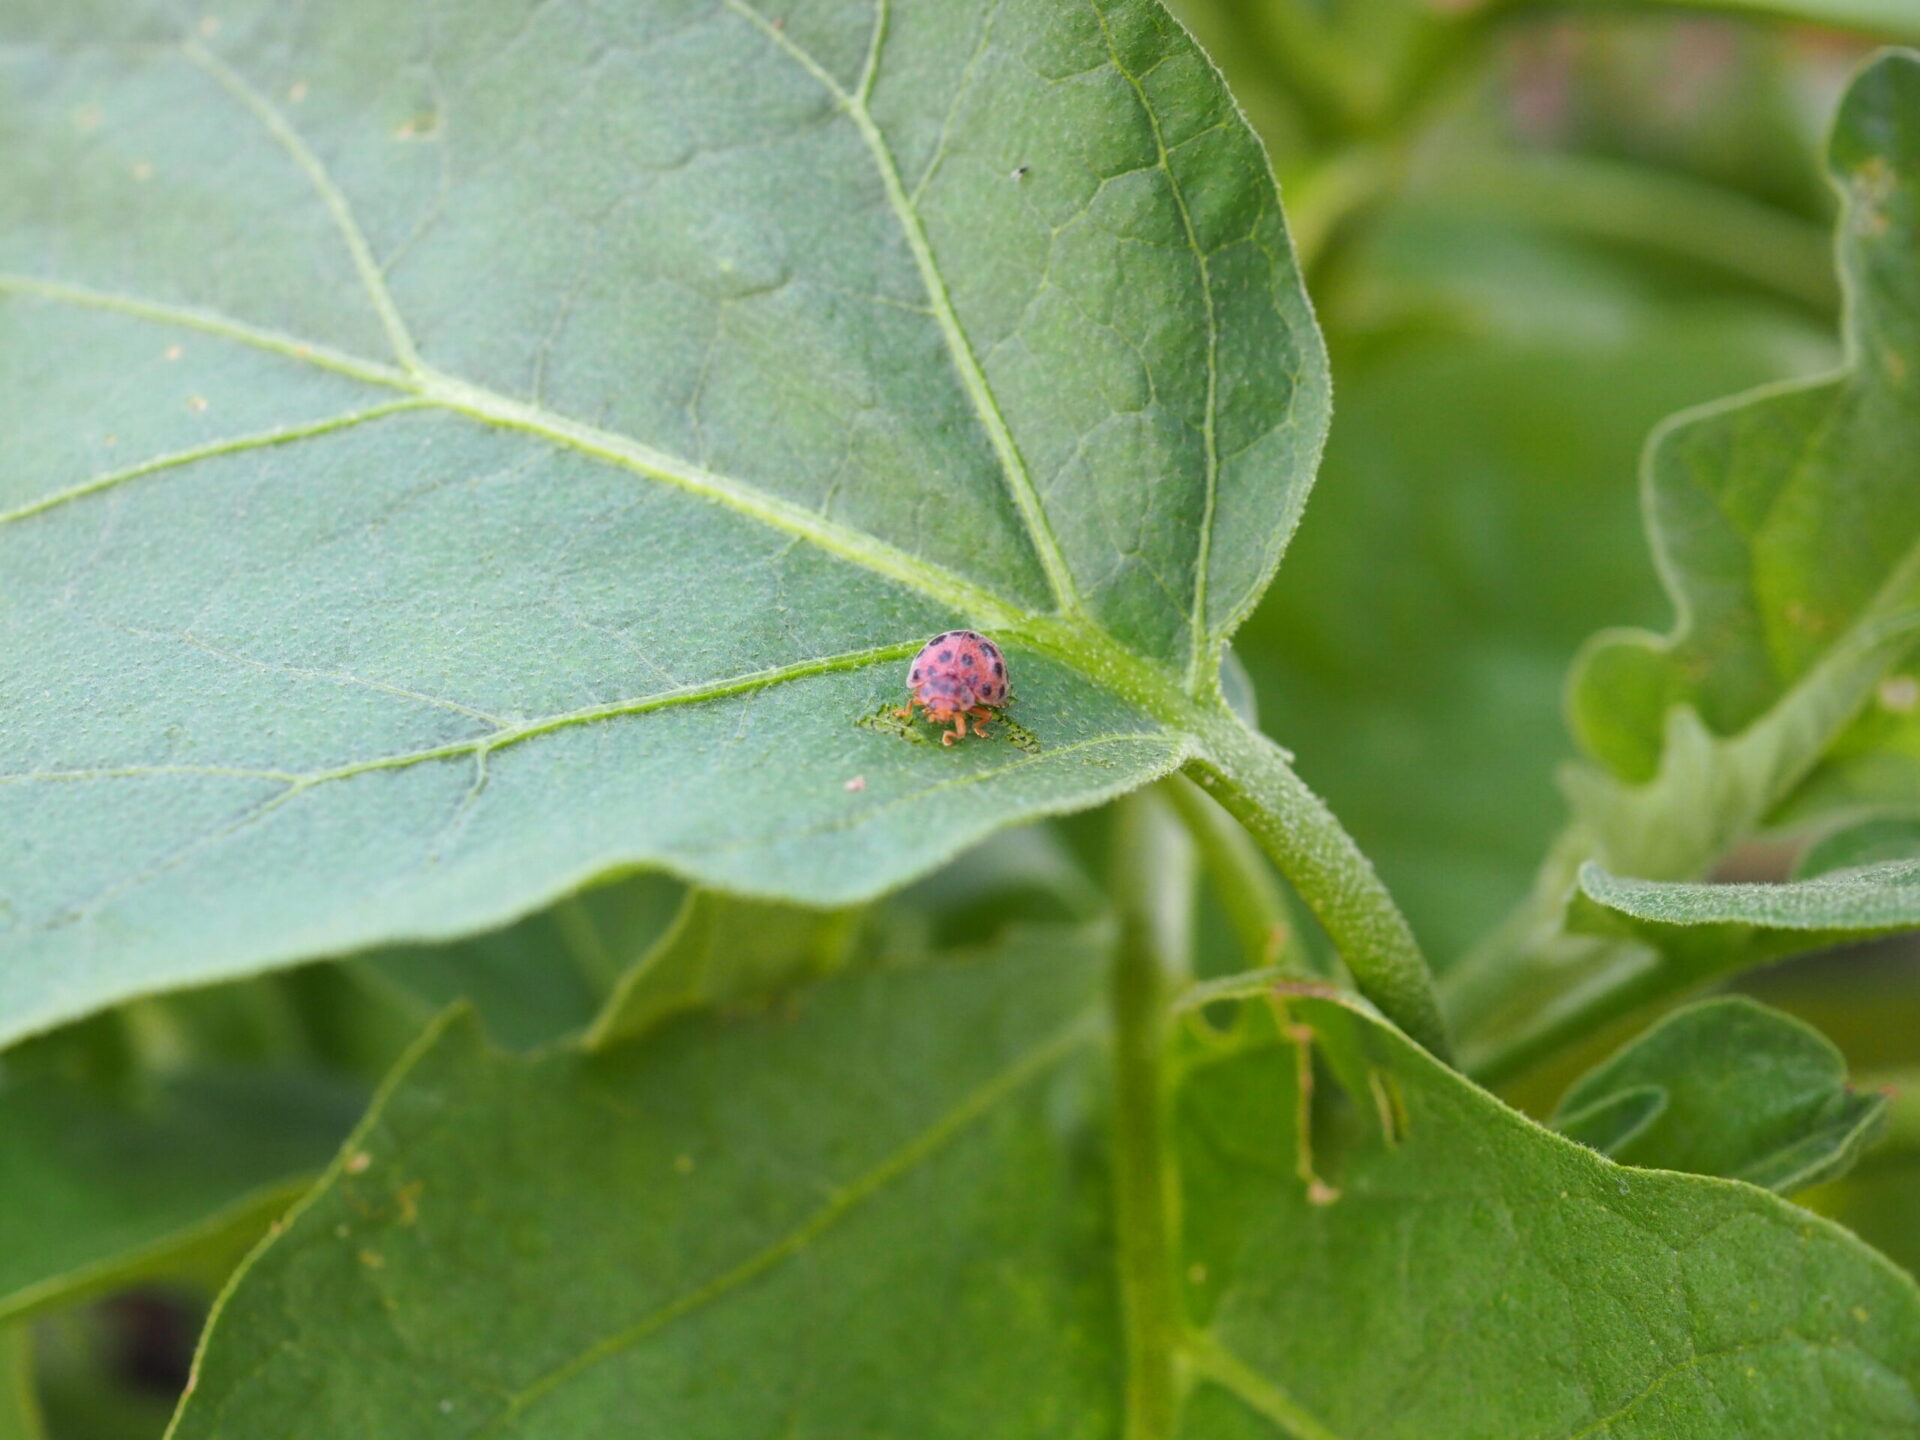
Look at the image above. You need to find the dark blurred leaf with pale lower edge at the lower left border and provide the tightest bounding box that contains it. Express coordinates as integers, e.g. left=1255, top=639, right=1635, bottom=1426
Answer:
left=0, top=1068, right=365, bottom=1319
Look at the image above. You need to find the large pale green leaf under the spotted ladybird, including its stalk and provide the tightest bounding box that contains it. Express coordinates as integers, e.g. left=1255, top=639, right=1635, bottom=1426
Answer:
left=0, top=0, right=1382, bottom=1044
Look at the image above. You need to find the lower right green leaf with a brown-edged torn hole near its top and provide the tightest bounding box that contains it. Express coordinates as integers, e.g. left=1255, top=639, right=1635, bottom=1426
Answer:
left=1181, top=996, right=1920, bottom=1440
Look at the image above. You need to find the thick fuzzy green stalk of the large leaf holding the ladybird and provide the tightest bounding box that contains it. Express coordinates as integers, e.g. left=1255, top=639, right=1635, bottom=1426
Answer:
left=1187, top=707, right=1450, bottom=1060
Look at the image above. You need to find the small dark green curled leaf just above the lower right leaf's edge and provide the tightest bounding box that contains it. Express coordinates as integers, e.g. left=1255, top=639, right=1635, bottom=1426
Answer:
left=1551, top=996, right=1887, bottom=1194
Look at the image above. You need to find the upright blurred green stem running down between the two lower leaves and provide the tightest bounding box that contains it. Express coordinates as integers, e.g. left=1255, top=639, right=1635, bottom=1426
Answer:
left=1112, top=795, right=1192, bottom=1440
